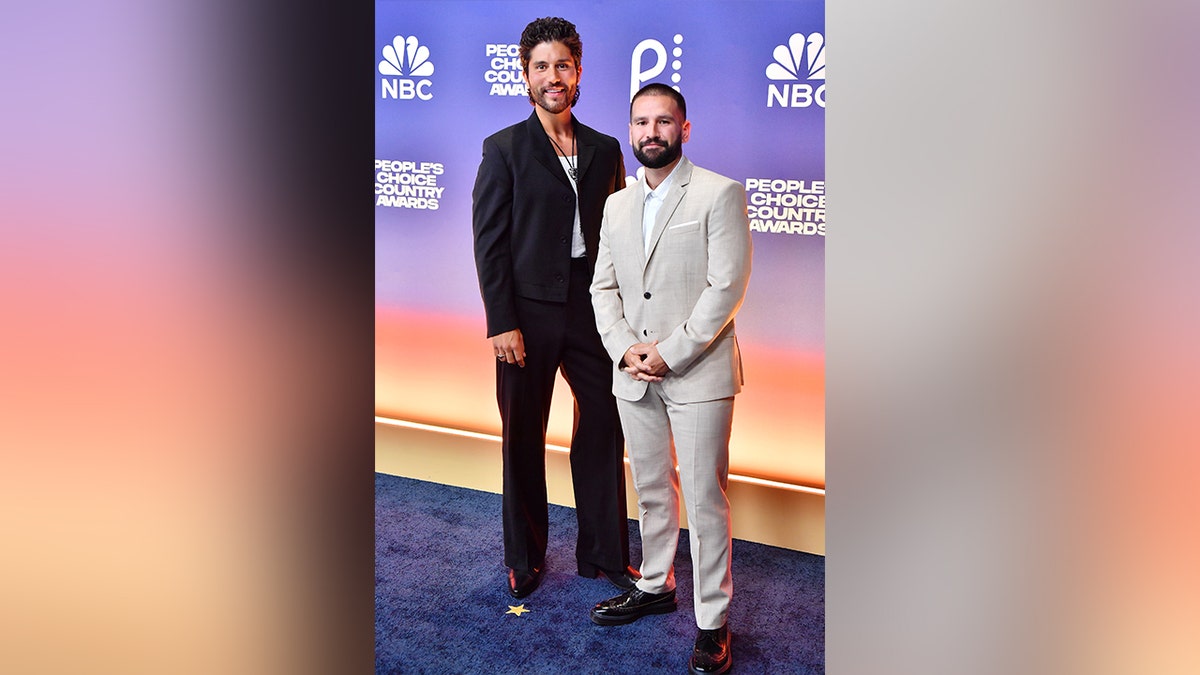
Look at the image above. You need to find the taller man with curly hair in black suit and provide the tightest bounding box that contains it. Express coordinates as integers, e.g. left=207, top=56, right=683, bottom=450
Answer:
left=472, top=18, right=637, bottom=598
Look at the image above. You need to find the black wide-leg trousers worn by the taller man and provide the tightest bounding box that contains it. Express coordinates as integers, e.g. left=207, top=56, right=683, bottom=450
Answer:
left=496, top=258, right=629, bottom=573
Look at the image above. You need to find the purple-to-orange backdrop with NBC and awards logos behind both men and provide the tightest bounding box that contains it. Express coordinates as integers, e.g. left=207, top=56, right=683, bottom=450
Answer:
left=374, top=0, right=827, bottom=488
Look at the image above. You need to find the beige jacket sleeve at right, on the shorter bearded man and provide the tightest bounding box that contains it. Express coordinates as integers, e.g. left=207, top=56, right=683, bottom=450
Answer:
left=658, top=181, right=751, bottom=372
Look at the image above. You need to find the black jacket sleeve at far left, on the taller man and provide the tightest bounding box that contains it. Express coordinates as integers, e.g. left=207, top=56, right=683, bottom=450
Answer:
left=470, top=138, right=520, bottom=338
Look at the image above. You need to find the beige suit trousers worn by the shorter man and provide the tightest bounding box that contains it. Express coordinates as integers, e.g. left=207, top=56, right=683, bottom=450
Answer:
left=617, top=382, right=733, bottom=629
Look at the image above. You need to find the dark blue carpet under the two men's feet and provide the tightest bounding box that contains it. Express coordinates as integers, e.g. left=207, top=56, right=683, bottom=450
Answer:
left=376, top=473, right=824, bottom=675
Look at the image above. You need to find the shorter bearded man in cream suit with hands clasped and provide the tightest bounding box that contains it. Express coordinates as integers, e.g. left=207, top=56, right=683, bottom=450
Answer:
left=592, top=84, right=751, bottom=673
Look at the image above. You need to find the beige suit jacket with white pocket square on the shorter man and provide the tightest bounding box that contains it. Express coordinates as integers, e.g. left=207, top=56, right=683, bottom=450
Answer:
left=592, top=157, right=751, bottom=402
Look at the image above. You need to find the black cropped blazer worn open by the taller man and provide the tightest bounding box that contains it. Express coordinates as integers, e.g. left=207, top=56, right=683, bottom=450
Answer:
left=472, top=112, right=625, bottom=336
